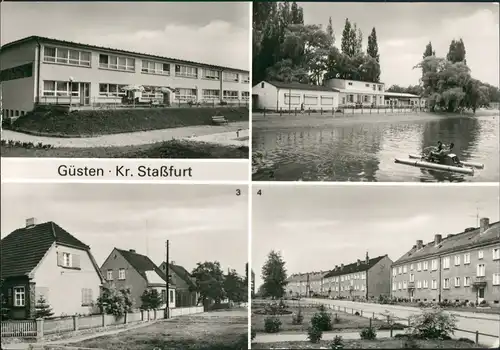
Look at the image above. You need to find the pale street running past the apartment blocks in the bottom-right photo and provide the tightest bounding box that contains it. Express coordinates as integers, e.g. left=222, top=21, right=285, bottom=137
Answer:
left=303, top=298, right=500, bottom=347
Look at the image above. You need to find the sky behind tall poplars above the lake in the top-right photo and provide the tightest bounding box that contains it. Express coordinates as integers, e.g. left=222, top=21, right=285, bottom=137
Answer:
left=299, top=2, right=500, bottom=86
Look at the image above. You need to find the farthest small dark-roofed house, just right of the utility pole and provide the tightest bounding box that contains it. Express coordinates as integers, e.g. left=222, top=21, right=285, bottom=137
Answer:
left=160, top=261, right=199, bottom=307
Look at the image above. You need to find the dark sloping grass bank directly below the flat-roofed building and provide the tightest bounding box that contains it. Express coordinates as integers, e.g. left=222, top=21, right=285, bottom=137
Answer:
left=12, top=107, right=249, bottom=137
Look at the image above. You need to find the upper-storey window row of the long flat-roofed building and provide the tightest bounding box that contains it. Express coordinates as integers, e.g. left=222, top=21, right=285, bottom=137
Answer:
left=43, top=46, right=250, bottom=83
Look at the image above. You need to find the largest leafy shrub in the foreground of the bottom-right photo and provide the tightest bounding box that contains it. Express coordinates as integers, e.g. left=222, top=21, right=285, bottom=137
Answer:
left=408, top=307, right=457, bottom=340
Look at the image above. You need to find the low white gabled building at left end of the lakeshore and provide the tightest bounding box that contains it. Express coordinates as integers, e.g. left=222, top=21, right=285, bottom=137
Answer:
left=252, top=81, right=339, bottom=111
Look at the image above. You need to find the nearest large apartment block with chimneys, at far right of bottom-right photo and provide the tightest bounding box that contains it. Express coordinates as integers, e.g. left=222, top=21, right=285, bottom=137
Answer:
left=392, top=218, right=500, bottom=304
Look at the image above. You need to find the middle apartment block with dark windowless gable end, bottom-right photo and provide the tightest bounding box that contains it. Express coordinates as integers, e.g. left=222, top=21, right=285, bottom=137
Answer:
left=323, top=253, right=392, bottom=299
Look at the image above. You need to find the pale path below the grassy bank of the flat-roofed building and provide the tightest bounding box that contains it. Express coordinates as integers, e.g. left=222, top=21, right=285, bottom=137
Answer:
left=2, top=122, right=249, bottom=148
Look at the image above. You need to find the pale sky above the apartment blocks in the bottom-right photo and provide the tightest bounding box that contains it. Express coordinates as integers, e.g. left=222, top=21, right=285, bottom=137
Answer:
left=252, top=185, right=500, bottom=287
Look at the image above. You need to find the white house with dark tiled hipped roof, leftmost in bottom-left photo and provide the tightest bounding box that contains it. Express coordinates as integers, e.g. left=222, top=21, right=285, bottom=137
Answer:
left=0, top=218, right=104, bottom=319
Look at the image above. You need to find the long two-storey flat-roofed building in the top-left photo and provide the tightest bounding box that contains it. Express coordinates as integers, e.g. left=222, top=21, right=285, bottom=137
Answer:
left=0, top=36, right=250, bottom=117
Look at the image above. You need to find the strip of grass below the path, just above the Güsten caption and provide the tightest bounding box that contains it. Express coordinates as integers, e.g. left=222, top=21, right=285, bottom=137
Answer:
left=0, top=140, right=249, bottom=159
